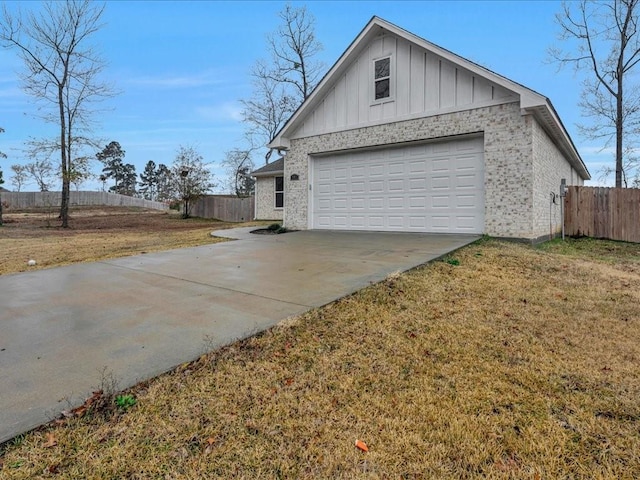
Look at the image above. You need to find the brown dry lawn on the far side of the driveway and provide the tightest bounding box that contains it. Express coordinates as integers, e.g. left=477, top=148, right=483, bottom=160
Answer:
left=0, top=207, right=262, bottom=275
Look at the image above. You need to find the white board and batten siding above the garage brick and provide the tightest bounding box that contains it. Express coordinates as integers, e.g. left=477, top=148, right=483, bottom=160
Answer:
left=291, top=34, right=517, bottom=138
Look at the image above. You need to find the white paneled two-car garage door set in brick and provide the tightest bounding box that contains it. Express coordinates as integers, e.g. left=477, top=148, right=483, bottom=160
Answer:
left=310, top=137, right=484, bottom=233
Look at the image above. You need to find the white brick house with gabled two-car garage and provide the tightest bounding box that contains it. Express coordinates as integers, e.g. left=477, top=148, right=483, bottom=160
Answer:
left=254, top=17, right=590, bottom=241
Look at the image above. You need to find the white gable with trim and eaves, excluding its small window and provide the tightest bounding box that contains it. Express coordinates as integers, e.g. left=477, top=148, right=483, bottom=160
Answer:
left=268, top=17, right=591, bottom=179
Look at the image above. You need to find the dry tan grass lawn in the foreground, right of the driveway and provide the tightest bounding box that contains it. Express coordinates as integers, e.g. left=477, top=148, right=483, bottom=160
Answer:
left=0, top=211, right=640, bottom=479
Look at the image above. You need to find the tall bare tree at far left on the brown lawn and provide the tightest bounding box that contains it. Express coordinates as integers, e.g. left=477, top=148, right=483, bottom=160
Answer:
left=0, top=0, right=112, bottom=227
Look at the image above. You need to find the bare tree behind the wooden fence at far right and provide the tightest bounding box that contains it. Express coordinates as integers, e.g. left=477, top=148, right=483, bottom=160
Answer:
left=549, top=0, right=640, bottom=187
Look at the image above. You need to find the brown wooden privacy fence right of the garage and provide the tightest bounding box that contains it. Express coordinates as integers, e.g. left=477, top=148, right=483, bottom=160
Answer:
left=564, top=186, right=640, bottom=242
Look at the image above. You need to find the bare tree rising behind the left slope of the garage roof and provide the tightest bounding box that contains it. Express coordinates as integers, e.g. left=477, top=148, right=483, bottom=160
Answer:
left=242, top=4, right=326, bottom=163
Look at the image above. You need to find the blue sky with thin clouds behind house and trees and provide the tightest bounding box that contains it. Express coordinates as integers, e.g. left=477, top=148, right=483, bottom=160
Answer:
left=0, top=1, right=612, bottom=190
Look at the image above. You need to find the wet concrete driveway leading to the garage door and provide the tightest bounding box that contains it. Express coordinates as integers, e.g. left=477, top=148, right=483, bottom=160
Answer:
left=0, top=228, right=478, bottom=442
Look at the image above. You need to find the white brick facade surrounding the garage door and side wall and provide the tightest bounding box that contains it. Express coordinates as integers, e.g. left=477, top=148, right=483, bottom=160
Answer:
left=284, top=102, right=578, bottom=240
